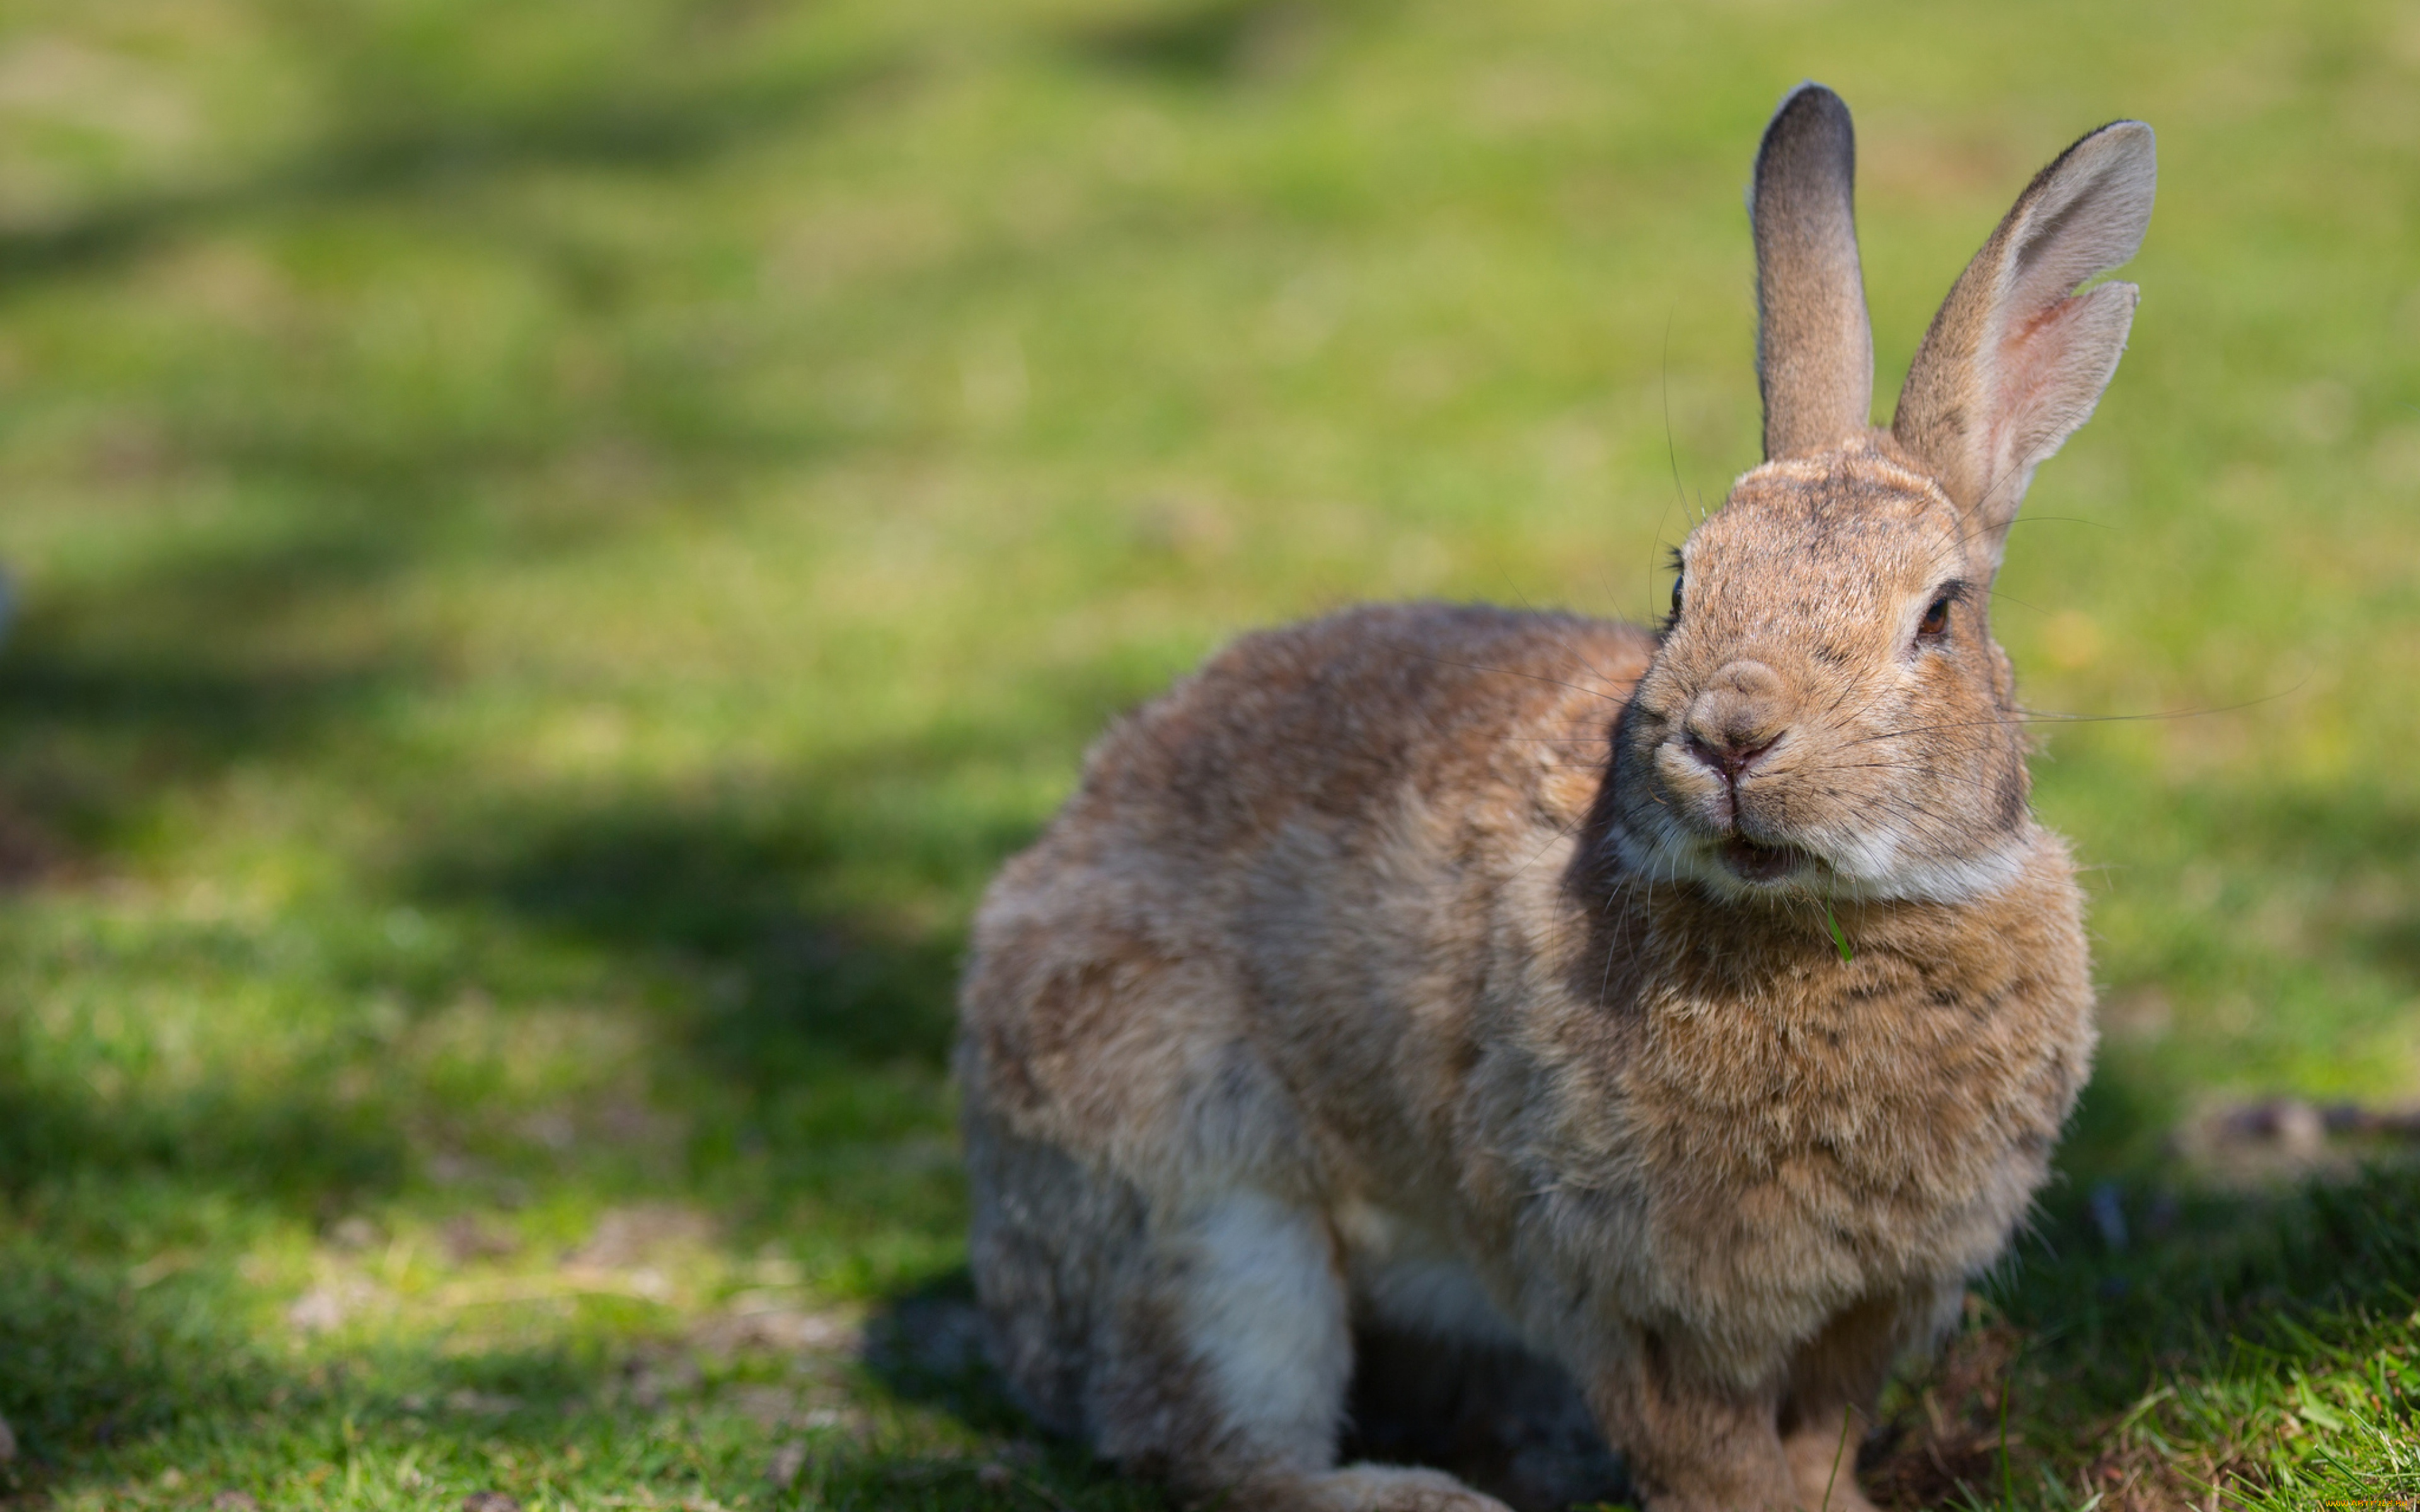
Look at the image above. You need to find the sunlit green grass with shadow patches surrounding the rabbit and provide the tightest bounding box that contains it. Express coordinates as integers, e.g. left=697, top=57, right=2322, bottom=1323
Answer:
left=0, top=0, right=2420, bottom=1509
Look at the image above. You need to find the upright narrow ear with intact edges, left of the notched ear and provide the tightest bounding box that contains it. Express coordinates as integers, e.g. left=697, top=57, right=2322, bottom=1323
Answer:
left=1747, top=83, right=1873, bottom=462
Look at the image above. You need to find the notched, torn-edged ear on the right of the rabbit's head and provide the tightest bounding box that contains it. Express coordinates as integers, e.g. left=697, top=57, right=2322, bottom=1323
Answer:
left=1890, top=121, right=2158, bottom=561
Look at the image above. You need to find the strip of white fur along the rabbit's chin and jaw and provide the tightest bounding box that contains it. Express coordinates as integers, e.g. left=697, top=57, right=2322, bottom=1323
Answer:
left=1611, top=815, right=2035, bottom=902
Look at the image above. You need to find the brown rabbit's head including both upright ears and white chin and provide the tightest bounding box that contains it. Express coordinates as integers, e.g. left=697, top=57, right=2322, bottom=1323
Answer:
left=1610, top=84, right=2154, bottom=902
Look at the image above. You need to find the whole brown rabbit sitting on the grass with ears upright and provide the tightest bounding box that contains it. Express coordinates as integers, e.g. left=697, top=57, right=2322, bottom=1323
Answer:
left=959, top=84, right=2154, bottom=1512
